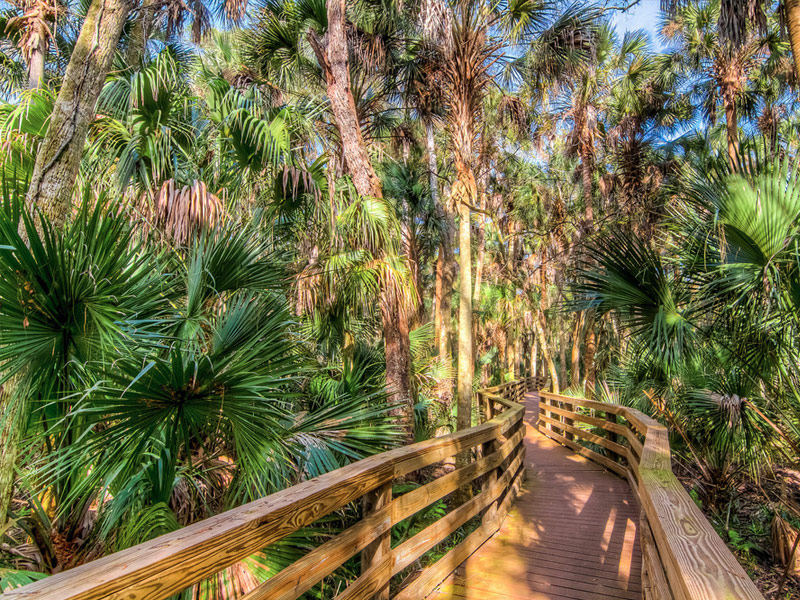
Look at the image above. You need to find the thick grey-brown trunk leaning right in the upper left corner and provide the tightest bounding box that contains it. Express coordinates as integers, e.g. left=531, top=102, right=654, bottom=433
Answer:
left=26, top=0, right=132, bottom=229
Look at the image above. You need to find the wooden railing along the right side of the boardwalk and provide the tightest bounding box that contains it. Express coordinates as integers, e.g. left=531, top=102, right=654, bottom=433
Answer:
left=538, top=392, right=763, bottom=600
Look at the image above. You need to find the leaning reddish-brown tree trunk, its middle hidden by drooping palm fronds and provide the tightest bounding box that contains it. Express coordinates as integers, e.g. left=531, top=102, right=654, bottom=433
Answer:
left=308, top=0, right=414, bottom=441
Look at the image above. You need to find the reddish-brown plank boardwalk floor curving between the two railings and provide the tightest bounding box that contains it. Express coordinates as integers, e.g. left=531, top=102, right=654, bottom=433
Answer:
left=429, top=393, right=642, bottom=600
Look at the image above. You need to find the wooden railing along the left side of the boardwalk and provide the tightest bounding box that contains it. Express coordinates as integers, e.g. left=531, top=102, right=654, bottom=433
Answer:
left=3, top=379, right=533, bottom=600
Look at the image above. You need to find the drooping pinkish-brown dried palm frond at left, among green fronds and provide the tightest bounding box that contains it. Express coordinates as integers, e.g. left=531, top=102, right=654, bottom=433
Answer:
left=152, top=179, right=224, bottom=245
